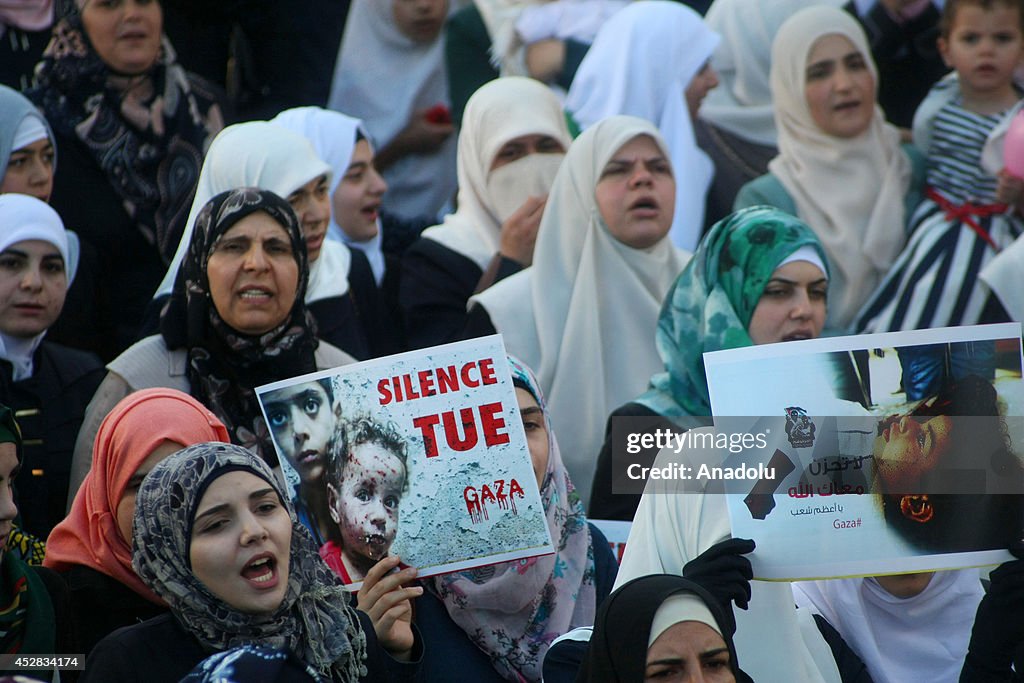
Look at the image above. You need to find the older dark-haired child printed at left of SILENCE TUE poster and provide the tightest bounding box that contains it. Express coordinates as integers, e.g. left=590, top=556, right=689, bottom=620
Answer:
left=262, top=379, right=344, bottom=545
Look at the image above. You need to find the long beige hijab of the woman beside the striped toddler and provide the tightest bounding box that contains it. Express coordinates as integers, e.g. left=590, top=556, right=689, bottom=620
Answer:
left=768, top=6, right=910, bottom=328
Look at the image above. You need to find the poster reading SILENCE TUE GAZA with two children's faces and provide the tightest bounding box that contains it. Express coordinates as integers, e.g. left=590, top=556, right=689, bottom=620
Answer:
left=256, top=335, right=554, bottom=589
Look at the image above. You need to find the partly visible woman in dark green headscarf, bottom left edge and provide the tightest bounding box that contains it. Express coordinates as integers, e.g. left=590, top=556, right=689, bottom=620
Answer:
left=0, top=405, right=75, bottom=681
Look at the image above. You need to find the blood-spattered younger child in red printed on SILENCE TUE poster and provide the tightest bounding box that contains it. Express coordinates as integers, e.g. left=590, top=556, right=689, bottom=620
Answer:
left=321, top=418, right=409, bottom=584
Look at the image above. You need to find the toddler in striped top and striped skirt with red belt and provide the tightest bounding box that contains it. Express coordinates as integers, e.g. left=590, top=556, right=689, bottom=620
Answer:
left=856, top=0, right=1024, bottom=332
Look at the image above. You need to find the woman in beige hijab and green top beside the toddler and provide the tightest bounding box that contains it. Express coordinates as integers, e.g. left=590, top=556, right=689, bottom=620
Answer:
left=734, top=6, right=924, bottom=330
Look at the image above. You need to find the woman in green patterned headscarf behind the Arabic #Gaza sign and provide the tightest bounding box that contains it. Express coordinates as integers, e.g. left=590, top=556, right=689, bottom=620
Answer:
left=589, top=206, right=828, bottom=519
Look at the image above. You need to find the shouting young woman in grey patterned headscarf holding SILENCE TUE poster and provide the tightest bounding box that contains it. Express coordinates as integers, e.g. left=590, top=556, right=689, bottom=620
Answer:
left=82, top=443, right=422, bottom=683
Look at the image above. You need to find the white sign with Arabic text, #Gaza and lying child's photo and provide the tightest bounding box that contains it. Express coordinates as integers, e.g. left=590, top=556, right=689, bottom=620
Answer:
left=700, top=324, right=1024, bottom=580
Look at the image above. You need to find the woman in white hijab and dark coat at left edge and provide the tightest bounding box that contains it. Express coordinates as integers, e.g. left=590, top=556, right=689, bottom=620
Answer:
left=0, top=194, right=104, bottom=539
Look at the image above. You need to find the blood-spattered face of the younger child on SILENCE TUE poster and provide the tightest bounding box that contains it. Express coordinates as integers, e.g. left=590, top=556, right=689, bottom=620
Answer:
left=331, top=442, right=406, bottom=569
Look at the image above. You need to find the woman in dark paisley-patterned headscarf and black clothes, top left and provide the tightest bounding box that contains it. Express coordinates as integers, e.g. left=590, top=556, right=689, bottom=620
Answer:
left=27, top=0, right=223, bottom=359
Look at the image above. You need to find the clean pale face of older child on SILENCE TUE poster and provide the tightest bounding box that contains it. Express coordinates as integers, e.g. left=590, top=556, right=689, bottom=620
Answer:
left=265, top=382, right=335, bottom=483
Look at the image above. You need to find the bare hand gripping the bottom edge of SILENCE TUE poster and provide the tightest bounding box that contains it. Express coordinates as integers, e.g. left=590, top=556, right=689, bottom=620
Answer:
left=356, top=555, right=423, bottom=660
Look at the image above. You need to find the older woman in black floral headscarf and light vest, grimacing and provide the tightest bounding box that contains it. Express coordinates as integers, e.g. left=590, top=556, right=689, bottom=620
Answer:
left=71, top=187, right=352, bottom=501
